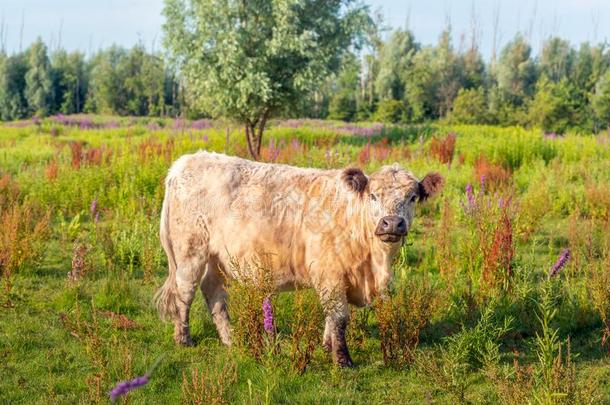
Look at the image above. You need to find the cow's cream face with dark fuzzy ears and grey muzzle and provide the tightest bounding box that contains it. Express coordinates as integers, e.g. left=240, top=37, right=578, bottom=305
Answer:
left=344, top=165, right=443, bottom=245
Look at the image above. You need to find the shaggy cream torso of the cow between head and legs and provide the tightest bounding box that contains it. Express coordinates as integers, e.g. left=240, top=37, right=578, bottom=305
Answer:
left=167, top=152, right=361, bottom=287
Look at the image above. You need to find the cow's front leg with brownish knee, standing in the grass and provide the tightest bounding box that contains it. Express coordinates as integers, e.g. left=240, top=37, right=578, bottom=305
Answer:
left=320, top=289, right=354, bottom=367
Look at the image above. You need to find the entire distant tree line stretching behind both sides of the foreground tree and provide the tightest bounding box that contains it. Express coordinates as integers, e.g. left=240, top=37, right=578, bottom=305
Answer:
left=0, top=26, right=610, bottom=133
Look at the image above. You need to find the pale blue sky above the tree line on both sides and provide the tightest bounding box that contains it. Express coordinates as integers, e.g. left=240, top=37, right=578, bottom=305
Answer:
left=0, top=0, right=610, bottom=57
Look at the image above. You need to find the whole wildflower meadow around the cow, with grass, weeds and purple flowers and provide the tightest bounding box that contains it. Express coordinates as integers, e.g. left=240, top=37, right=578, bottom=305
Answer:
left=0, top=116, right=610, bottom=404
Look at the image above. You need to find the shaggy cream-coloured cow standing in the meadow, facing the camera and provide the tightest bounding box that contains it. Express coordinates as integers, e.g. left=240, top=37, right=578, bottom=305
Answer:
left=155, top=151, right=443, bottom=367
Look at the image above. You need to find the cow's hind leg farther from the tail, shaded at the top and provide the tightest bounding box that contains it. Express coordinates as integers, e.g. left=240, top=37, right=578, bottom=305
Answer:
left=201, top=258, right=231, bottom=346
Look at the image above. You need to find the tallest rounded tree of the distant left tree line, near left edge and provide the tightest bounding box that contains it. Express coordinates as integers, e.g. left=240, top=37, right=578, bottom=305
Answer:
left=25, top=38, right=54, bottom=117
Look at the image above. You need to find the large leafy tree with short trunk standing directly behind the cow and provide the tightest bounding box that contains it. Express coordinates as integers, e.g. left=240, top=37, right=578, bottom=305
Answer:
left=163, top=0, right=370, bottom=159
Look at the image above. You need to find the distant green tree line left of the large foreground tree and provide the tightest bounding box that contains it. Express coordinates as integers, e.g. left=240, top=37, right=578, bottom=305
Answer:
left=0, top=39, right=181, bottom=121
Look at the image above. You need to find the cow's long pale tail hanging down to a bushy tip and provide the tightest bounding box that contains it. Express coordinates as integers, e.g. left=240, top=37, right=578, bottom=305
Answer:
left=153, top=175, right=178, bottom=321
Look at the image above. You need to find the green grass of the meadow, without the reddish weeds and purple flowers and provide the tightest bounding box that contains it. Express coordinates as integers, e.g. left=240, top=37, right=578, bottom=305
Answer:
left=0, top=117, right=610, bottom=404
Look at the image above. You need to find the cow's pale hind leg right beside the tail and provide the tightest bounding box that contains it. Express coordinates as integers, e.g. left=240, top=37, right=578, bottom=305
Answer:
left=174, top=255, right=206, bottom=346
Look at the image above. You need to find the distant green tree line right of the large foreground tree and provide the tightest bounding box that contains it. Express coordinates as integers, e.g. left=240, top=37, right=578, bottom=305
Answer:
left=328, top=29, right=610, bottom=133
